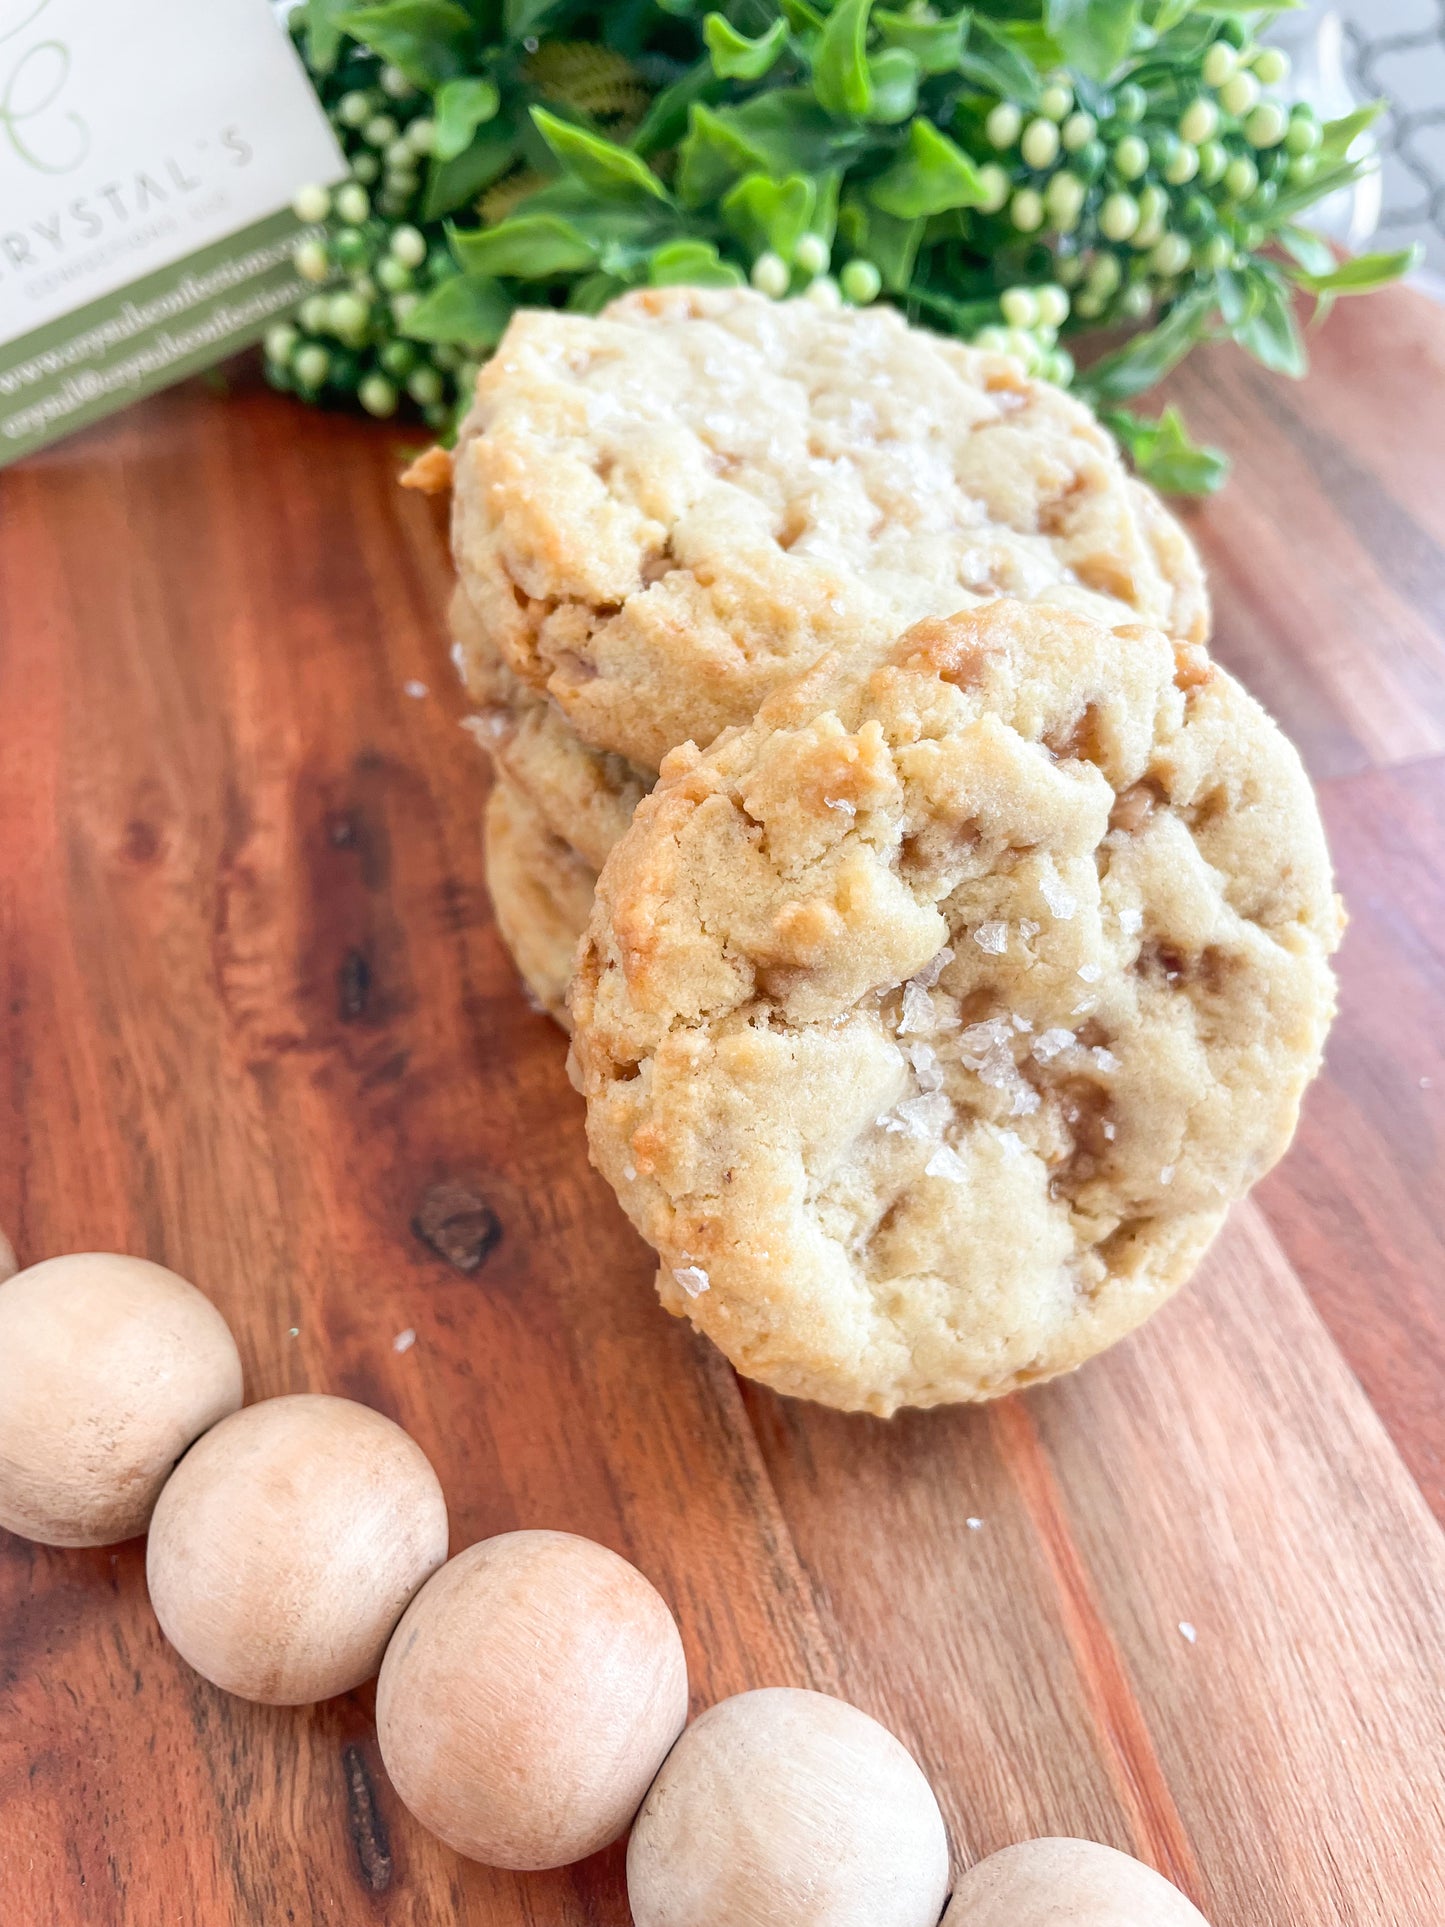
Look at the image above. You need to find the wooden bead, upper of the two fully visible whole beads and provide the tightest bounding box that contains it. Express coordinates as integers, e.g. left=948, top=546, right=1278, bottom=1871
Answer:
left=146, top=1393, right=447, bottom=1705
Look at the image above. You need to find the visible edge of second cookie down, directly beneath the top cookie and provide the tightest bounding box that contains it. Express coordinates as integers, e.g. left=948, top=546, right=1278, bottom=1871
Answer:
left=449, top=586, right=657, bottom=878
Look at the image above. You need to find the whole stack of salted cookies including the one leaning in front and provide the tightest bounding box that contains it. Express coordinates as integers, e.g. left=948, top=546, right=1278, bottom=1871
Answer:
left=453, top=289, right=1339, bottom=1412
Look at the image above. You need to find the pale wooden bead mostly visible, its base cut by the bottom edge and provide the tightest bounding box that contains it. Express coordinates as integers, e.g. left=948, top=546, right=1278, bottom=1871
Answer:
left=628, top=1686, right=948, bottom=1927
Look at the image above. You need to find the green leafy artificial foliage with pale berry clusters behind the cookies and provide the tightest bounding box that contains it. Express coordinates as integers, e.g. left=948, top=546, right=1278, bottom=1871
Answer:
left=266, top=0, right=1412, bottom=491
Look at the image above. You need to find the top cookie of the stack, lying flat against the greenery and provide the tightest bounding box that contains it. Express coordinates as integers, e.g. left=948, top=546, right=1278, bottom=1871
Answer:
left=453, top=287, right=1208, bottom=771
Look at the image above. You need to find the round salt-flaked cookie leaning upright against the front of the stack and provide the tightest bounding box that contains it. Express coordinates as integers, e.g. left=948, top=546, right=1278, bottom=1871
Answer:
left=572, top=599, right=1341, bottom=1412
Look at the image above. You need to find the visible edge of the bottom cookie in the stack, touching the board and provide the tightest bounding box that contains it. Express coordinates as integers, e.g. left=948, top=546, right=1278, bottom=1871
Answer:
left=486, top=777, right=597, bottom=1029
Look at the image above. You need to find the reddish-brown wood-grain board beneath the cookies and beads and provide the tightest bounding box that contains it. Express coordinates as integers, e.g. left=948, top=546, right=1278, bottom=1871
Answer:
left=0, top=295, right=1445, bottom=1927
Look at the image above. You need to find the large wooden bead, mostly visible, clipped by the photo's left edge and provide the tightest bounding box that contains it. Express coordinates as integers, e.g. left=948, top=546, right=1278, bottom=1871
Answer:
left=0, top=1245, right=241, bottom=1545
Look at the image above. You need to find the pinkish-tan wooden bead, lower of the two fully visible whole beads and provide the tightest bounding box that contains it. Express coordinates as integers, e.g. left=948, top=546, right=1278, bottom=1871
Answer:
left=376, top=1532, right=688, bottom=1867
